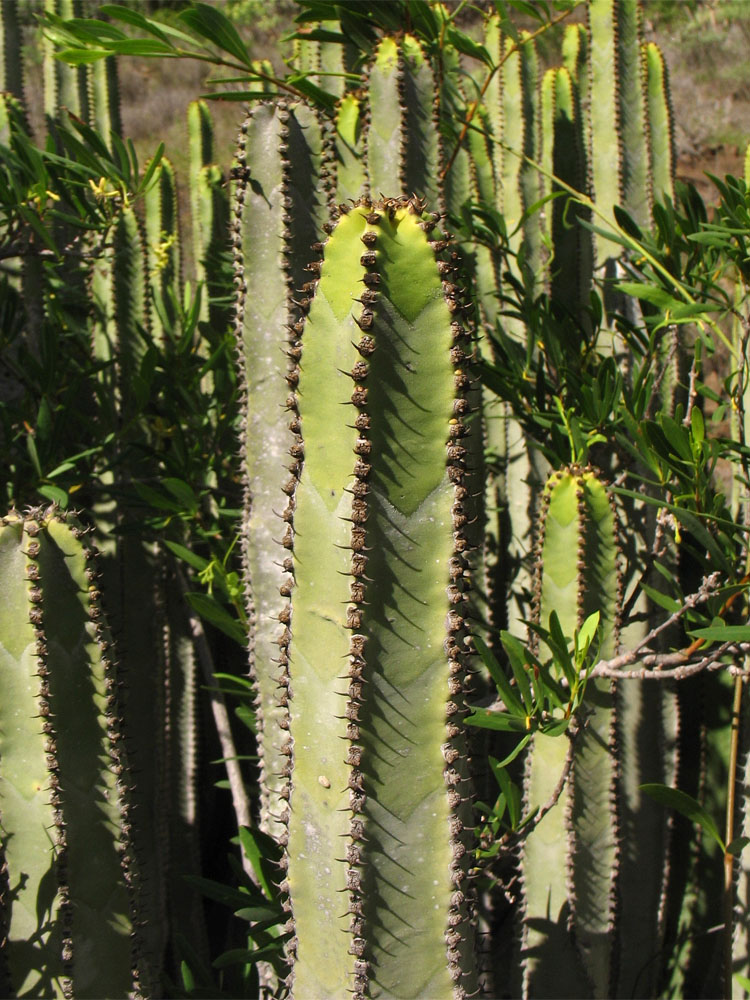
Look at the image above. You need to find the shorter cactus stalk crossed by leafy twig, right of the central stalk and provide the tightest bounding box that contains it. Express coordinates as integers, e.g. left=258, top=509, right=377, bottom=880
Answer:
left=521, top=468, right=620, bottom=997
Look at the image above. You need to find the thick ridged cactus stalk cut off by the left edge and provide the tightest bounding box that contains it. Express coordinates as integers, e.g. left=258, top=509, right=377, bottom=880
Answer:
left=0, top=510, right=140, bottom=997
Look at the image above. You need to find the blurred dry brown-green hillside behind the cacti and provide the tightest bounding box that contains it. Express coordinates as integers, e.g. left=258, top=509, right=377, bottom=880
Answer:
left=14, top=0, right=750, bottom=220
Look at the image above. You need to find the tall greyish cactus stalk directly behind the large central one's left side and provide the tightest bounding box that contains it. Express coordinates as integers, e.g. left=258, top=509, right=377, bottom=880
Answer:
left=233, top=104, right=326, bottom=837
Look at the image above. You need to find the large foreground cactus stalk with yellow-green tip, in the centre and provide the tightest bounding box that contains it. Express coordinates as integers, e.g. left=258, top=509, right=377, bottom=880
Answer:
left=287, top=200, right=475, bottom=998
